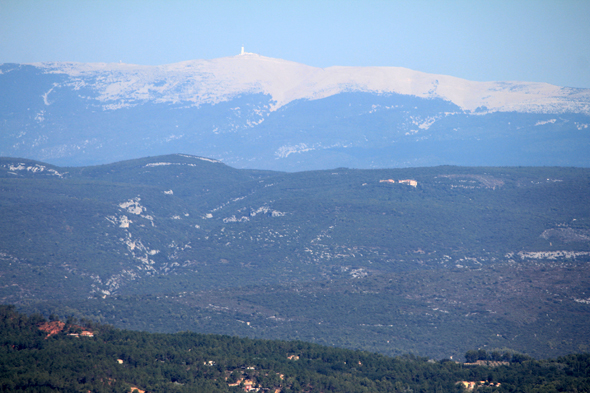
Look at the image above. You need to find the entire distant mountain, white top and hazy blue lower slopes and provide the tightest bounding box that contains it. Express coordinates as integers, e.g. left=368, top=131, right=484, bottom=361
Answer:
left=0, top=53, right=590, bottom=170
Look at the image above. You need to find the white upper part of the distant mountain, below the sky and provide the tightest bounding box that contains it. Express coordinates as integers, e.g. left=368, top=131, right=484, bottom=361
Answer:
left=34, top=53, right=590, bottom=114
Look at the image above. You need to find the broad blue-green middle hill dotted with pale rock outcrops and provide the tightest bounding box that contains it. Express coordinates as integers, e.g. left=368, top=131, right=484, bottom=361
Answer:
left=0, top=154, right=590, bottom=359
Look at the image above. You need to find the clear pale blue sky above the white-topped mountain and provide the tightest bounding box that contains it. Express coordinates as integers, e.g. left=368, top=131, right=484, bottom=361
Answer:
left=0, top=0, right=590, bottom=88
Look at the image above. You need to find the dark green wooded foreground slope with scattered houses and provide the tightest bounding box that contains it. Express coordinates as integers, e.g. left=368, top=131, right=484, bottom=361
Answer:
left=0, top=306, right=590, bottom=393
